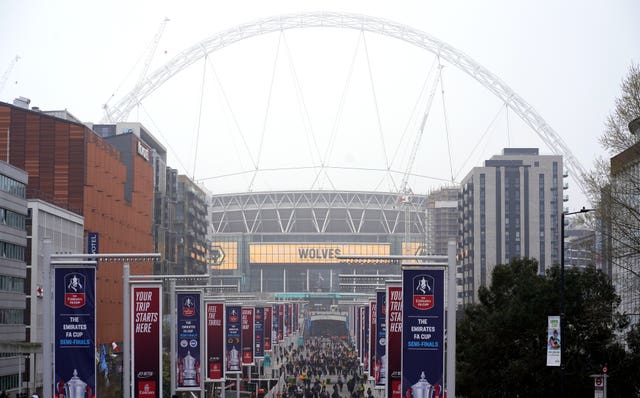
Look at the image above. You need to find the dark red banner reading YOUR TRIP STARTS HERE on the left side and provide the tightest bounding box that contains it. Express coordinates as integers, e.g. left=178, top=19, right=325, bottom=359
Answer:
left=131, top=285, right=162, bottom=398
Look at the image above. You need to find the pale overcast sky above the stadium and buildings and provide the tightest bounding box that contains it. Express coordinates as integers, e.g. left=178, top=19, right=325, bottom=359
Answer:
left=0, top=0, right=640, bottom=208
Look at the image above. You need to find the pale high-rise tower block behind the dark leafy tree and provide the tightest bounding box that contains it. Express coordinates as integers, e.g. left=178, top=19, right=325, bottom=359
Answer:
left=458, top=148, right=564, bottom=304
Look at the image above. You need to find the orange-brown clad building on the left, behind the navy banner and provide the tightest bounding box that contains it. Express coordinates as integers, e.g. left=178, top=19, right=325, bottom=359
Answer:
left=0, top=102, right=153, bottom=343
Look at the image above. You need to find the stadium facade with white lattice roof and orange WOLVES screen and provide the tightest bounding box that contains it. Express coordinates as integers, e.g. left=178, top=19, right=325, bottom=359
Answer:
left=209, top=191, right=427, bottom=293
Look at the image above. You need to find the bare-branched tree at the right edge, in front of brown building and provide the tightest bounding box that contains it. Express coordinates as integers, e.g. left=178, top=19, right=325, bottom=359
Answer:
left=585, top=64, right=640, bottom=338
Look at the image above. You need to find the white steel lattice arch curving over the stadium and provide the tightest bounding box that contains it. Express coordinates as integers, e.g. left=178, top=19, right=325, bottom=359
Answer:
left=103, top=12, right=587, bottom=194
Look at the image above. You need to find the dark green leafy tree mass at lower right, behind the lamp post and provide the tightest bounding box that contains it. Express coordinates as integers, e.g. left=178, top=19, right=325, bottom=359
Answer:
left=457, top=259, right=639, bottom=397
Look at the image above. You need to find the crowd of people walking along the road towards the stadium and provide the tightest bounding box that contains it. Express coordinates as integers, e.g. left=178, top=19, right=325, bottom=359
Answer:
left=278, top=337, right=373, bottom=398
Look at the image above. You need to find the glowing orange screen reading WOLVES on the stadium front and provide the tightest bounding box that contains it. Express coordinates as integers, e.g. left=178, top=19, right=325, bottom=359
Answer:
left=249, top=243, right=391, bottom=264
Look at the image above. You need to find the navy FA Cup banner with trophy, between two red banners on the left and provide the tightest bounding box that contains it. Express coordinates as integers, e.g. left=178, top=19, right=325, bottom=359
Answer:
left=176, top=292, right=202, bottom=391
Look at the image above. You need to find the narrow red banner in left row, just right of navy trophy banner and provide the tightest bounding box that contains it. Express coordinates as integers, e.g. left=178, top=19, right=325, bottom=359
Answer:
left=205, top=301, right=224, bottom=381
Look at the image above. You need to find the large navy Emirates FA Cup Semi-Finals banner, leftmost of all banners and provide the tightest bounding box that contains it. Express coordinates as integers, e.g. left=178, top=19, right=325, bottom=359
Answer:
left=53, top=267, right=96, bottom=398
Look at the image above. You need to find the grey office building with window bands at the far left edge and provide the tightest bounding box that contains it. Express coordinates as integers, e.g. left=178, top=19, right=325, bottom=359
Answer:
left=0, top=161, right=28, bottom=392
